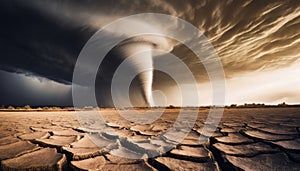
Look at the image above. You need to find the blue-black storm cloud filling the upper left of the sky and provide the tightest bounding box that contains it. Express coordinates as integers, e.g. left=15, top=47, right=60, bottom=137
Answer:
left=0, top=1, right=94, bottom=82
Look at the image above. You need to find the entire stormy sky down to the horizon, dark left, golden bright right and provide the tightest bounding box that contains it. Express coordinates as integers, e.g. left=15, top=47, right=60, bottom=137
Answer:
left=0, top=0, right=300, bottom=106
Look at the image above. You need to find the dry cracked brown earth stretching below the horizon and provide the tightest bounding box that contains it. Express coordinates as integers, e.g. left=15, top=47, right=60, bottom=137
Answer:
left=0, top=108, right=300, bottom=170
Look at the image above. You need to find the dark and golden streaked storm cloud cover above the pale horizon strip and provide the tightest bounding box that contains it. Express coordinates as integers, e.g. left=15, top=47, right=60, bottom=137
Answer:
left=0, top=0, right=300, bottom=106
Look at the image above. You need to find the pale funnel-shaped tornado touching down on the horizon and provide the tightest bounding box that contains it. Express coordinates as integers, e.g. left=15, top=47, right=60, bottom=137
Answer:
left=117, top=35, right=172, bottom=107
